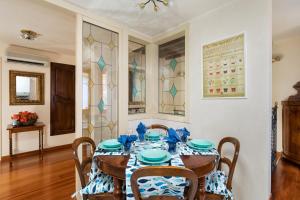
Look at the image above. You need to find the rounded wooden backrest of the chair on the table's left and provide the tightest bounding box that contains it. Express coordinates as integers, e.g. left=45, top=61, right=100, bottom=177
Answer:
left=72, top=137, right=96, bottom=188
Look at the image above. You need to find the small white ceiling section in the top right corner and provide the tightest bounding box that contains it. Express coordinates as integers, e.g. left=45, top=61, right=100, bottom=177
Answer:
left=273, top=0, right=300, bottom=41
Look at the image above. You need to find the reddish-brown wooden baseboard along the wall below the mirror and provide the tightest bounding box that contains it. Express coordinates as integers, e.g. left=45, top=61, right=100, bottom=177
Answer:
left=1, top=144, right=72, bottom=162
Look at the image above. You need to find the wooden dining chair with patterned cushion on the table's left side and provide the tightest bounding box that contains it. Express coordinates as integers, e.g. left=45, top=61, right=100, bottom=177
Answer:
left=72, top=137, right=113, bottom=200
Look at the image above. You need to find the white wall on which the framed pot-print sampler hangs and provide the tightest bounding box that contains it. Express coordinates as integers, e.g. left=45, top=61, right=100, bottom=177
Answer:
left=188, top=0, right=272, bottom=200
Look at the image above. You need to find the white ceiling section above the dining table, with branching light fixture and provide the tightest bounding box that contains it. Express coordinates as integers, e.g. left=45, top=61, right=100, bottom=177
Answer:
left=64, top=0, right=233, bottom=36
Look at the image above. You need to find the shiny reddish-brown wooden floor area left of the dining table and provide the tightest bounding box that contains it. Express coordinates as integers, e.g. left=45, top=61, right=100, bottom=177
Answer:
left=0, top=149, right=75, bottom=200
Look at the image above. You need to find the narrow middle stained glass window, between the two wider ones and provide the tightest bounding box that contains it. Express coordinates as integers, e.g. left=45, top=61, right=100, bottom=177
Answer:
left=128, top=41, right=146, bottom=114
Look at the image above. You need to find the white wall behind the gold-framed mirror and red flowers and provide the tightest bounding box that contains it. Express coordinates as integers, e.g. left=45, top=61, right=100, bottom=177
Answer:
left=1, top=45, right=75, bottom=156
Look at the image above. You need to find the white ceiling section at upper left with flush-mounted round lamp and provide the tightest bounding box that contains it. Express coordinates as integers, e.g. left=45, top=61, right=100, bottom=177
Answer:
left=0, top=0, right=76, bottom=55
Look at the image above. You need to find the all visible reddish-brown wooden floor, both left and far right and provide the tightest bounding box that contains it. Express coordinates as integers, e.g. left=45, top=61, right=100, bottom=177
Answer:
left=0, top=149, right=300, bottom=200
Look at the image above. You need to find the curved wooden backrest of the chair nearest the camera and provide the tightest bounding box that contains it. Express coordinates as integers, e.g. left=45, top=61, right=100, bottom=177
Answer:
left=130, top=166, right=198, bottom=200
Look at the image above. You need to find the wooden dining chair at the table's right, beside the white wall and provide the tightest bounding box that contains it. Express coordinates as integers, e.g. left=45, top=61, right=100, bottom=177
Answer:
left=205, top=137, right=240, bottom=200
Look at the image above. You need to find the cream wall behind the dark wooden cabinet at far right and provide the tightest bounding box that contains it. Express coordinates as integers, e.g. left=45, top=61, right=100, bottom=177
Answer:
left=272, top=37, right=300, bottom=151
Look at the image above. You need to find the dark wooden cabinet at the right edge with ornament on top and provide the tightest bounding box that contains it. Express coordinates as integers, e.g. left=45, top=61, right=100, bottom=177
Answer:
left=282, top=81, right=300, bottom=164
